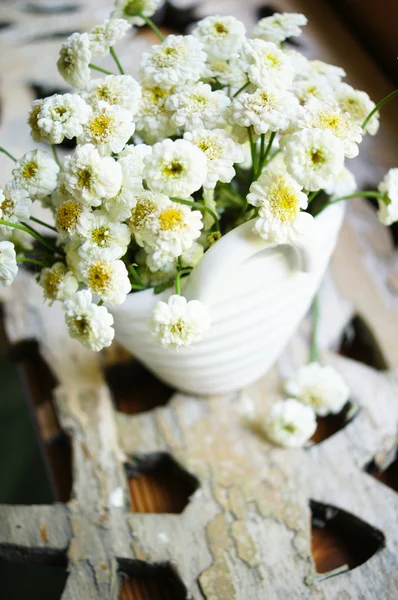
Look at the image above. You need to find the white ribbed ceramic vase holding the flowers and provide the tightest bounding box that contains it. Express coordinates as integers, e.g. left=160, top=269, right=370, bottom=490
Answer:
left=112, top=204, right=344, bottom=394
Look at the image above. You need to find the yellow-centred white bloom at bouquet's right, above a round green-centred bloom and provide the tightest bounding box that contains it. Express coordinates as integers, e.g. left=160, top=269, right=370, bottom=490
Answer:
left=304, top=98, right=362, bottom=158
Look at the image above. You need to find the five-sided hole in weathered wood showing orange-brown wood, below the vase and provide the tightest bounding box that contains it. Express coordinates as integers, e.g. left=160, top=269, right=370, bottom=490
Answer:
left=126, top=454, right=199, bottom=514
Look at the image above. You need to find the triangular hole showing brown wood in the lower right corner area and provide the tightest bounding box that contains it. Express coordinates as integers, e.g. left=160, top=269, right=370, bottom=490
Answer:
left=310, top=500, right=385, bottom=573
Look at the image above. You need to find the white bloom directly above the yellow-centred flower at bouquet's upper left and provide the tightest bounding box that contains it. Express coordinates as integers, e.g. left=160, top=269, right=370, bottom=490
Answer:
left=82, top=75, right=141, bottom=115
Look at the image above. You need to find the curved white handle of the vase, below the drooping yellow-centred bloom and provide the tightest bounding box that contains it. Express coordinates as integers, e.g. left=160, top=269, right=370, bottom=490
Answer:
left=183, top=220, right=316, bottom=304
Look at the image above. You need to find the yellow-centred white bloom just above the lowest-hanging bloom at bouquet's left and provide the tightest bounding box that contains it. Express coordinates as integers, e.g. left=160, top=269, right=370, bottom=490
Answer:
left=78, top=259, right=131, bottom=306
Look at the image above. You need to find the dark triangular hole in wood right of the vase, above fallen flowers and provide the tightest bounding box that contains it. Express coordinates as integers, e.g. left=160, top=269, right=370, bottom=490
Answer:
left=339, top=315, right=387, bottom=371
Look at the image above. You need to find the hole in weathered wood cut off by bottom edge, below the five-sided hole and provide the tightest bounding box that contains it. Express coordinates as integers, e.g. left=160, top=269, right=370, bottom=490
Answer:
left=119, top=561, right=187, bottom=600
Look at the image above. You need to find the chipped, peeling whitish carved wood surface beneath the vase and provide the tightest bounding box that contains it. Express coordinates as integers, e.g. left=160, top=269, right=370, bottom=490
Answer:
left=0, top=0, right=398, bottom=600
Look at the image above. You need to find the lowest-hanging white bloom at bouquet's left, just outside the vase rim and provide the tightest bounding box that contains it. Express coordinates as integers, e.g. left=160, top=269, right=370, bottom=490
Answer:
left=63, top=290, right=115, bottom=352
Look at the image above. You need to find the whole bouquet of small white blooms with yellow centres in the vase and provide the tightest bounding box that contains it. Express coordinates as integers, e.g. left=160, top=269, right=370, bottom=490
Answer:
left=0, top=0, right=398, bottom=350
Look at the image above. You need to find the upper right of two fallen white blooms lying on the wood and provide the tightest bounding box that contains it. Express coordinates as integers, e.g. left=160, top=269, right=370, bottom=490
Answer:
left=285, top=363, right=350, bottom=417
